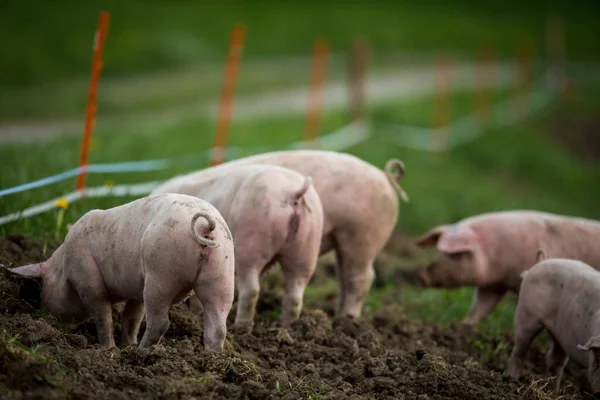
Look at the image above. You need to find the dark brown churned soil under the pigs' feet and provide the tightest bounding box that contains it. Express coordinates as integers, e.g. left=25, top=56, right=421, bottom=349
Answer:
left=0, top=236, right=589, bottom=400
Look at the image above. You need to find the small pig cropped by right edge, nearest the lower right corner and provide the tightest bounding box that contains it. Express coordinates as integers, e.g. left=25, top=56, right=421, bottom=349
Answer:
left=508, top=253, right=600, bottom=394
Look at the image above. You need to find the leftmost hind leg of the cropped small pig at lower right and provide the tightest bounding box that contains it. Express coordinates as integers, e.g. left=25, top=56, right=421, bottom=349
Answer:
left=508, top=303, right=544, bottom=379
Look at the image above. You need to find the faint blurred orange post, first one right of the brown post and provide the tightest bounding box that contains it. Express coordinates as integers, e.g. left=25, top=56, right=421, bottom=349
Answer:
left=430, top=58, right=454, bottom=152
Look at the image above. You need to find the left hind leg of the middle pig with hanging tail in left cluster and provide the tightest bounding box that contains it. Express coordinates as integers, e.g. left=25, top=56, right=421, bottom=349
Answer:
left=233, top=266, right=261, bottom=333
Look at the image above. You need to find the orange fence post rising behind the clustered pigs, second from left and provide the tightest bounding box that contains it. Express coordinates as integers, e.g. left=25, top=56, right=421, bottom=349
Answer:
left=210, top=25, right=246, bottom=167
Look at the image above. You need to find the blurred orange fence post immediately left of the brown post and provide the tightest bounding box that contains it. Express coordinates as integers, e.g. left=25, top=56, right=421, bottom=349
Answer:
left=304, top=39, right=329, bottom=147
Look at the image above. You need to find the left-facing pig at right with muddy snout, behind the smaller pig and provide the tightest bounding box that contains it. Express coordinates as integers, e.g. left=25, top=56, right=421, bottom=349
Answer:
left=416, top=210, right=600, bottom=325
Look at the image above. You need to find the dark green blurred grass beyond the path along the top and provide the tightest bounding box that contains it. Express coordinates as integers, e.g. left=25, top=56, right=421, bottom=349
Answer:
left=0, top=0, right=600, bottom=86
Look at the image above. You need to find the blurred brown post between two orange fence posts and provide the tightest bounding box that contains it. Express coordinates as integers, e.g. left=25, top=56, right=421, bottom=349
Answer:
left=348, top=40, right=371, bottom=122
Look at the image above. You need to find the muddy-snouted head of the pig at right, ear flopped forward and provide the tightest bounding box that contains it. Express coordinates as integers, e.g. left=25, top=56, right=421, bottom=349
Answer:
left=416, top=224, right=488, bottom=289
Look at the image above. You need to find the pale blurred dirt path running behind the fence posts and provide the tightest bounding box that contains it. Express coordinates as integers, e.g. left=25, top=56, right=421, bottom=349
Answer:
left=0, top=63, right=512, bottom=144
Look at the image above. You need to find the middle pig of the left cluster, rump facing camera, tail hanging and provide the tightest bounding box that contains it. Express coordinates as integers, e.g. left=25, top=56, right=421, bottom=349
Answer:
left=153, top=165, right=323, bottom=333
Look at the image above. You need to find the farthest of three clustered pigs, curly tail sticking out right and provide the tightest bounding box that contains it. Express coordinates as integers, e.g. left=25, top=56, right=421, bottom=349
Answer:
left=166, top=150, right=408, bottom=317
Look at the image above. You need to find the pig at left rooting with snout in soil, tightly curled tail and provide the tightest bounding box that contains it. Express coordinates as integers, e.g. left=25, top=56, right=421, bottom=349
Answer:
left=12, top=194, right=235, bottom=351
